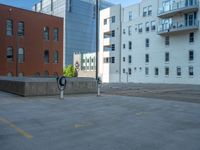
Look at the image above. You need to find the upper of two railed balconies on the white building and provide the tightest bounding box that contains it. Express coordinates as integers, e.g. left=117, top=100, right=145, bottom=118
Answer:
left=158, top=0, right=199, bottom=18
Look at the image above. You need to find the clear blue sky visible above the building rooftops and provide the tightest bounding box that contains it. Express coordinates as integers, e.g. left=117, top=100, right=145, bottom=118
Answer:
left=0, top=0, right=140, bottom=9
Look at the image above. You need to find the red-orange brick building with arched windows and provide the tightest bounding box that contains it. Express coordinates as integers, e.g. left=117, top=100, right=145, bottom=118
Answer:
left=0, top=4, right=63, bottom=76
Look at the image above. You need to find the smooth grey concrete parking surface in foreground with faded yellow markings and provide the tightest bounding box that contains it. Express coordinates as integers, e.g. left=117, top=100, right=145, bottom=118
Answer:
left=0, top=92, right=200, bottom=150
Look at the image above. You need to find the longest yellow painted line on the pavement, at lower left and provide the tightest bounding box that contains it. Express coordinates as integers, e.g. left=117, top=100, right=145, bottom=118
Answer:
left=0, top=117, right=33, bottom=140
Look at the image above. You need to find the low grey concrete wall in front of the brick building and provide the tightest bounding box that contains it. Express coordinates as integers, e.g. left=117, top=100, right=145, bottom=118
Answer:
left=0, top=77, right=97, bottom=96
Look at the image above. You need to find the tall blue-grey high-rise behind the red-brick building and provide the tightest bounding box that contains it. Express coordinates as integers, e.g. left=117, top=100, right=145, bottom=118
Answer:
left=32, top=0, right=112, bottom=66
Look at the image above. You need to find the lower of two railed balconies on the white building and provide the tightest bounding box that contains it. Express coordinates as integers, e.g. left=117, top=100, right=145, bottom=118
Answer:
left=158, top=20, right=199, bottom=35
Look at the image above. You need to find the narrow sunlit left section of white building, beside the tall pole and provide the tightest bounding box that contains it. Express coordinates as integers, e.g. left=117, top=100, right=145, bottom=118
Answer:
left=99, top=5, right=121, bottom=82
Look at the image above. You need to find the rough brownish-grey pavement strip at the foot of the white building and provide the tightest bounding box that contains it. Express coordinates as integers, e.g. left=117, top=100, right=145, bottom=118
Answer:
left=102, top=83, right=200, bottom=103
